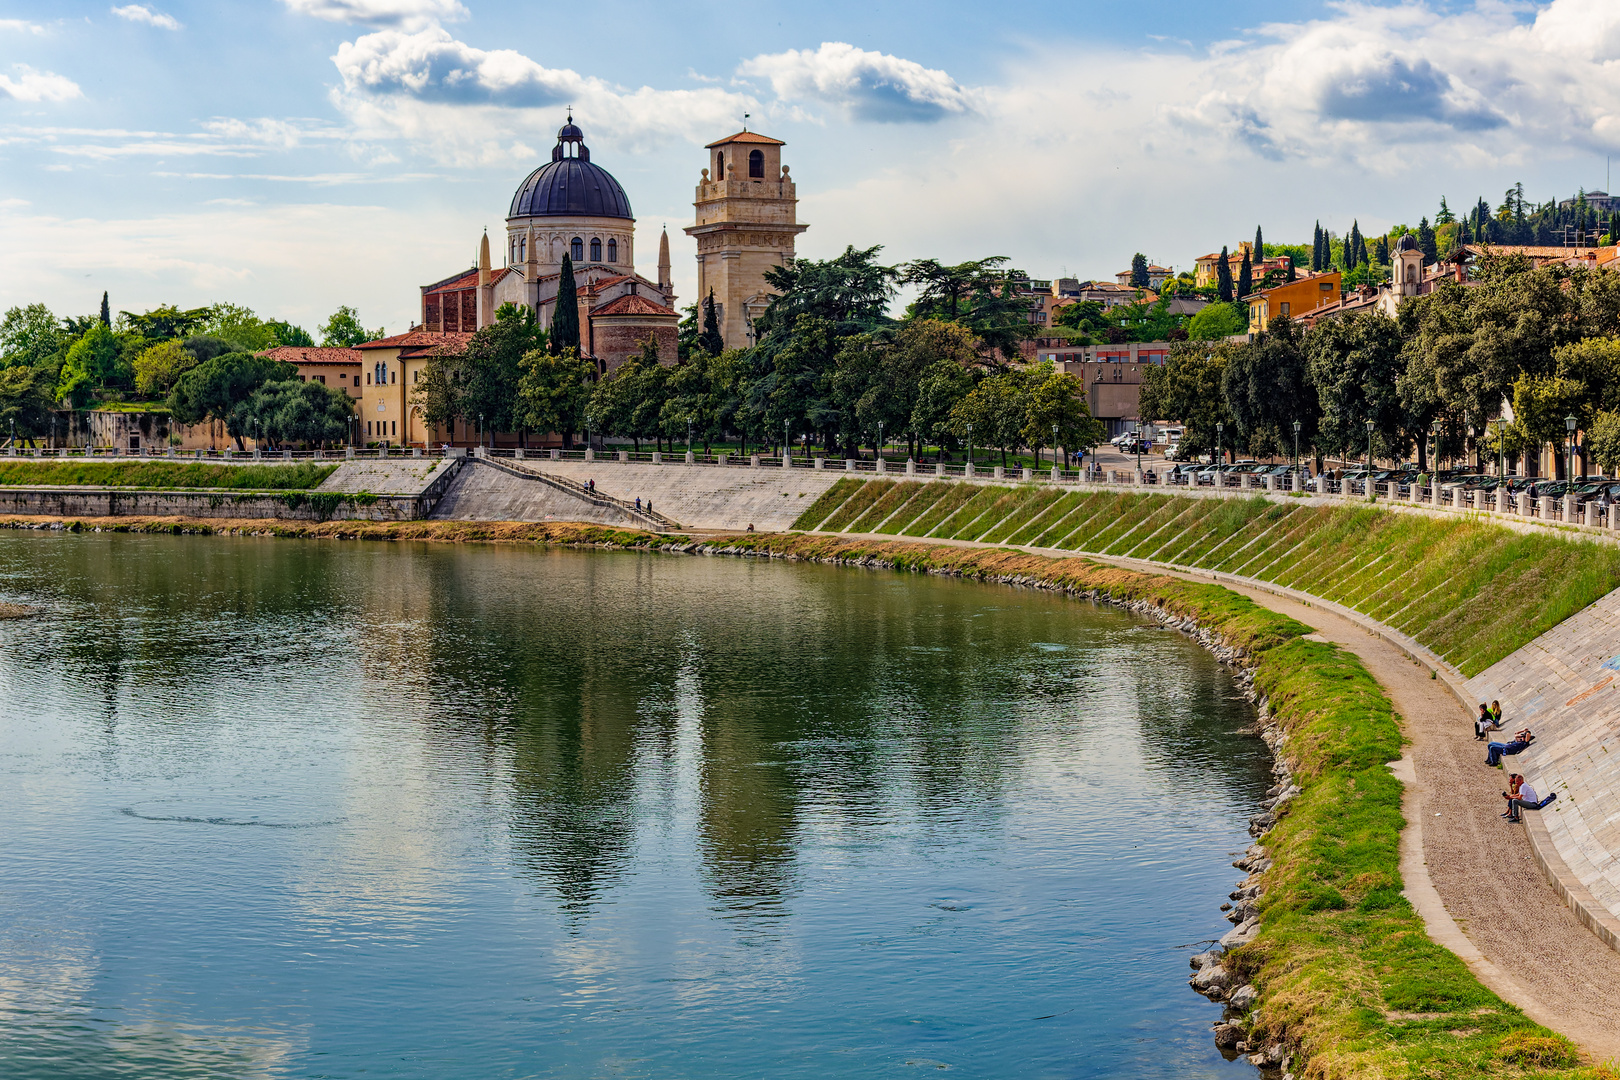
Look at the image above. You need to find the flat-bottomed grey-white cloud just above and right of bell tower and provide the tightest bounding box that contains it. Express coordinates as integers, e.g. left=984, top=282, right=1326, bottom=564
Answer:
left=737, top=42, right=977, bottom=123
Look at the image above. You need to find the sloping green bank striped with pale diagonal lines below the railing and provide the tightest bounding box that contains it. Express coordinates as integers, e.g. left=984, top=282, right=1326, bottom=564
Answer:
left=794, top=478, right=1620, bottom=677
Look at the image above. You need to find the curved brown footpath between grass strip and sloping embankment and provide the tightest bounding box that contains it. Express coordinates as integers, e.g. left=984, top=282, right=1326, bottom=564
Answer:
left=839, top=533, right=1620, bottom=1061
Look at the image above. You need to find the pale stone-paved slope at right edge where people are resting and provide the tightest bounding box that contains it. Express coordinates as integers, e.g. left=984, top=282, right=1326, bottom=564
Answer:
left=1468, top=591, right=1620, bottom=949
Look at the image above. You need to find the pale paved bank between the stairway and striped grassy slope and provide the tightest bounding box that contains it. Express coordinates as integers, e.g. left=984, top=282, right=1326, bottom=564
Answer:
left=492, top=460, right=844, bottom=531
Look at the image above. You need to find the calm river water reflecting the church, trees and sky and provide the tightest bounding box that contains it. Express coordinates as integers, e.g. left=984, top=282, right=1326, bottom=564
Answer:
left=0, top=534, right=1268, bottom=1080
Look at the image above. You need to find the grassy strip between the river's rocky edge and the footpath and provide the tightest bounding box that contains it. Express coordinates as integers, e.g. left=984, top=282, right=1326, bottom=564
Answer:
left=699, top=534, right=1594, bottom=1080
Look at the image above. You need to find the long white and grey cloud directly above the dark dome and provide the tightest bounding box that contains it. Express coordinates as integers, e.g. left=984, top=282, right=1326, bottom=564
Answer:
left=332, top=26, right=753, bottom=165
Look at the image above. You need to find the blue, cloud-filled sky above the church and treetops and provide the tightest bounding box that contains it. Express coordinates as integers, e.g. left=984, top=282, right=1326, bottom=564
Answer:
left=0, top=0, right=1620, bottom=332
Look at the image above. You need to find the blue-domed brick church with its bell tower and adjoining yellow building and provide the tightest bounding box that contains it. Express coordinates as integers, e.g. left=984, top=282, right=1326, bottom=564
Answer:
left=360, top=117, right=805, bottom=444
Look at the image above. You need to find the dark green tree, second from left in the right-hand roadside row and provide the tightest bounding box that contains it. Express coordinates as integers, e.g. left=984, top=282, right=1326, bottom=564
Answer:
left=1221, top=316, right=1320, bottom=455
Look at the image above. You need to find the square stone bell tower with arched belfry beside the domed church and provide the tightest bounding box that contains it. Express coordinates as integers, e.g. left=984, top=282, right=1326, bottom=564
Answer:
left=687, top=130, right=808, bottom=348
